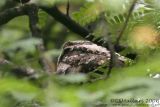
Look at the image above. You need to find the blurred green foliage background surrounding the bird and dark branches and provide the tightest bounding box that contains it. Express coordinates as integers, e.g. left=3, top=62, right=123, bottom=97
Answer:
left=0, top=0, right=160, bottom=107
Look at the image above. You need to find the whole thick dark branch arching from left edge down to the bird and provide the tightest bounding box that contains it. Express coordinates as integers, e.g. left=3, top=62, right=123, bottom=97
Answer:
left=0, top=4, right=123, bottom=51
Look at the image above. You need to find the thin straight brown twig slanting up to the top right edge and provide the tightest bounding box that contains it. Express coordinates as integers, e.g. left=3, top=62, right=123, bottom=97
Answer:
left=115, top=0, right=137, bottom=46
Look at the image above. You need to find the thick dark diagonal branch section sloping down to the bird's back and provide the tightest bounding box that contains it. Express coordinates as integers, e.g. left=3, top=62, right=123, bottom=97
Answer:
left=40, top=6, right=124, bottom=51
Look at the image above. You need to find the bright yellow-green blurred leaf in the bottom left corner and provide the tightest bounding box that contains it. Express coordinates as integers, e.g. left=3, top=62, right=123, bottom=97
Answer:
left=0, top=77, right=42, bottom=107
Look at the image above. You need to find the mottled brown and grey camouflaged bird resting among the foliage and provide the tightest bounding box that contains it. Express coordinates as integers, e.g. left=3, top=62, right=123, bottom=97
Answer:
left=57, top=41, right=127, bottom=74
